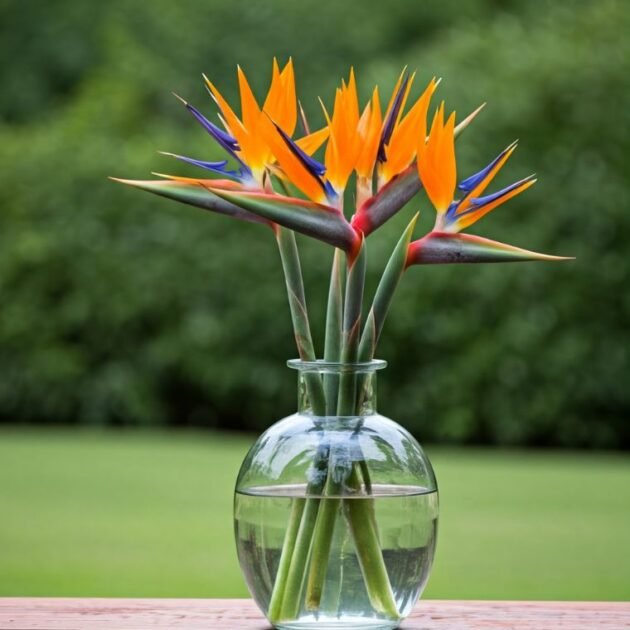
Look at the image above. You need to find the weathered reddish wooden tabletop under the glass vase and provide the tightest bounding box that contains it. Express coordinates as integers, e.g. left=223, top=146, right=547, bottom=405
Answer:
left=0, top=597, right=630, bottom=630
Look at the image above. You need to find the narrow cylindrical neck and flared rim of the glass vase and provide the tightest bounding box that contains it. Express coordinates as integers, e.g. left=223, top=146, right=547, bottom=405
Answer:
left=288, top=360, right=387, bottom=417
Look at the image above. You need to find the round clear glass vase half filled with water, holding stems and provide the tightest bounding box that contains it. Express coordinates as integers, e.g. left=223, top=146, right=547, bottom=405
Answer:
left=234, top=360, right=438, bottom=630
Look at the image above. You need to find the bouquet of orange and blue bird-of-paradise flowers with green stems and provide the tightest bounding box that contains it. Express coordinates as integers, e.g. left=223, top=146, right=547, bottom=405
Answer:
left=112, top=59, right=561, bottom=627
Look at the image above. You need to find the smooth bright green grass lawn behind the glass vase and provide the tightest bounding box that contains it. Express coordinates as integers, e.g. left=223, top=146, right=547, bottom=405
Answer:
left=0, top=430, right=630, bottom=600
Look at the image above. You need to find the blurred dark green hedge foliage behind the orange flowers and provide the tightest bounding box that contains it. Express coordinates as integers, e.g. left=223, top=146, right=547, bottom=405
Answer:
left=0, top=0, right=630, bottom=447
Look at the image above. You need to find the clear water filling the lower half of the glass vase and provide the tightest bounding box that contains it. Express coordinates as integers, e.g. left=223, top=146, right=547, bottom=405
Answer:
left=235, top=485, right=438, bottom=630
